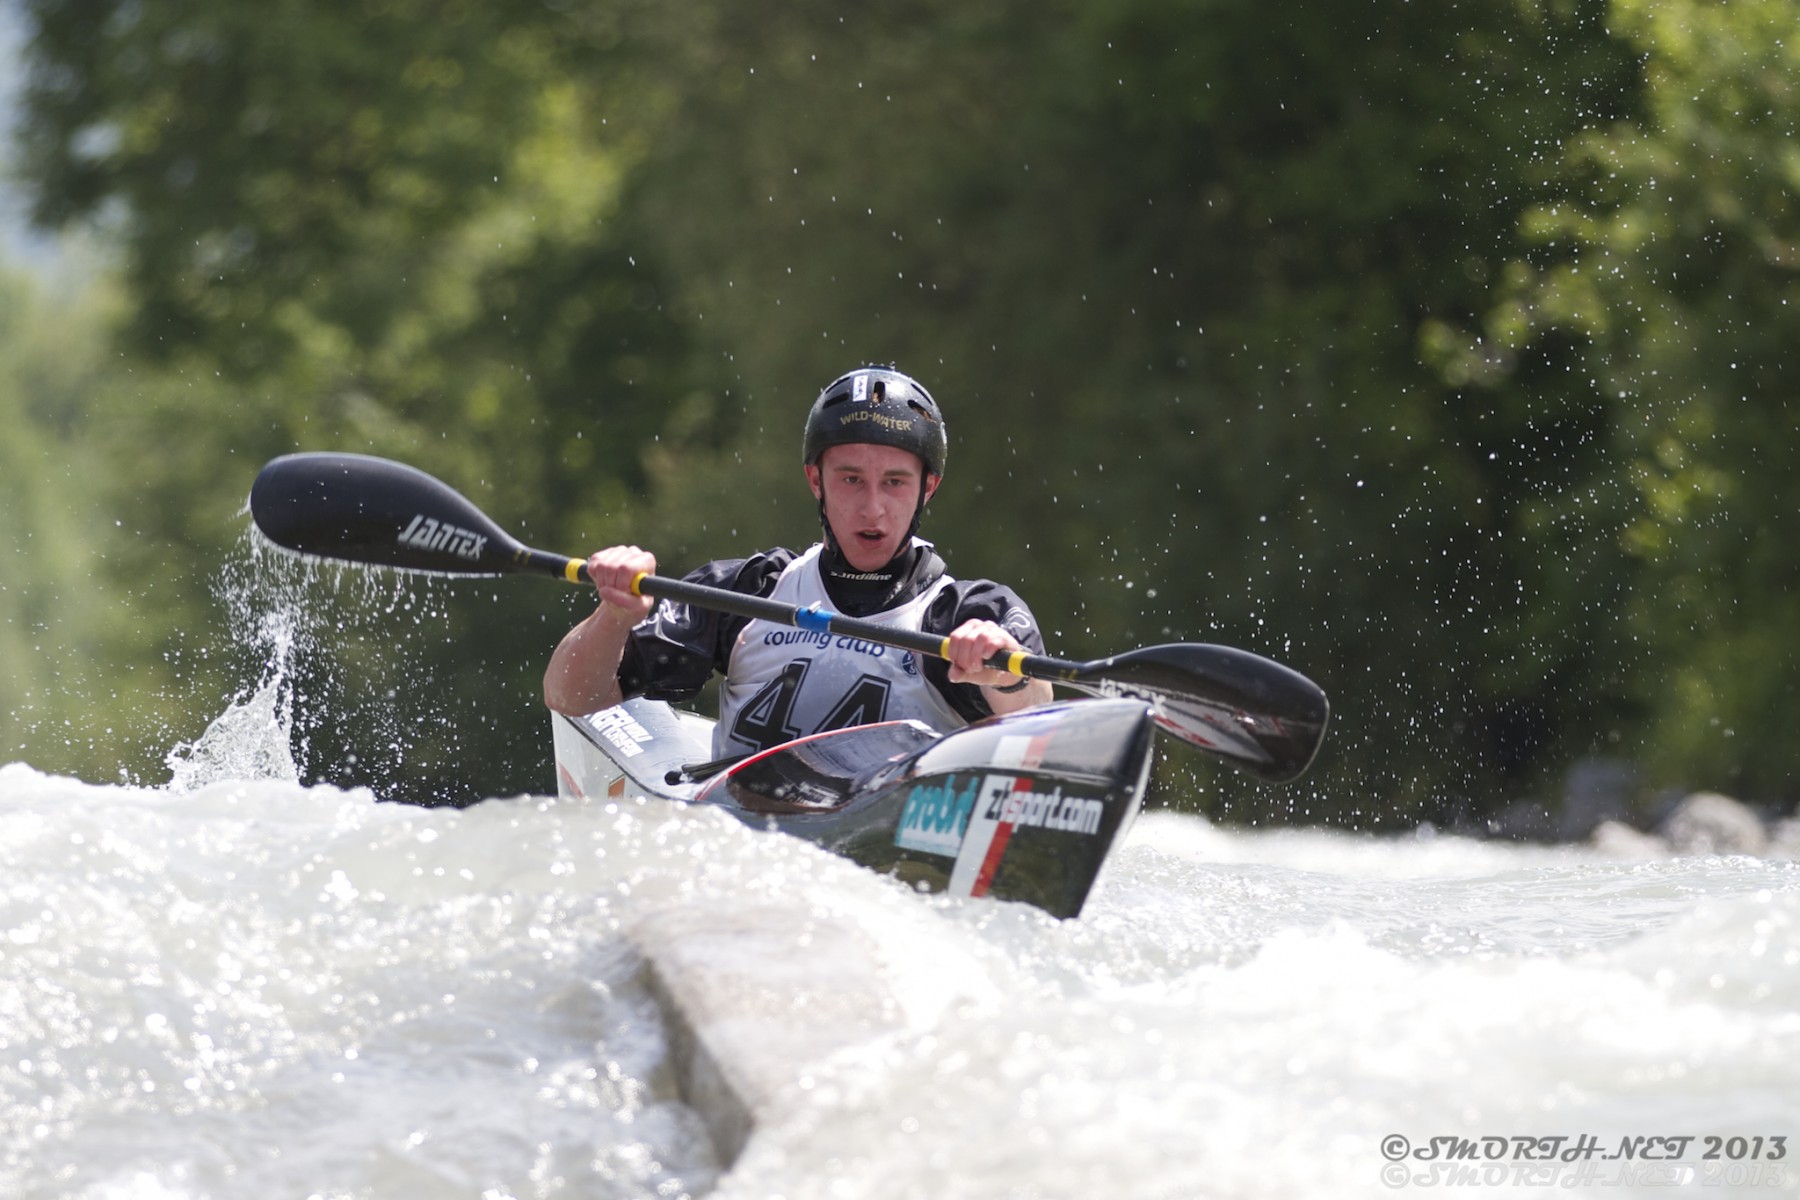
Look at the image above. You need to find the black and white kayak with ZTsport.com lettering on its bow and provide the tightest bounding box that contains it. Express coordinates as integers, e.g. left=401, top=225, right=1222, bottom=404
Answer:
left=553, top=698, right=1157, bottom=918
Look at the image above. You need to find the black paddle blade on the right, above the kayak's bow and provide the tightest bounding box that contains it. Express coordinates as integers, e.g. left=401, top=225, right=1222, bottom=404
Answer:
left=1069, top=644, right=1330, bottom=783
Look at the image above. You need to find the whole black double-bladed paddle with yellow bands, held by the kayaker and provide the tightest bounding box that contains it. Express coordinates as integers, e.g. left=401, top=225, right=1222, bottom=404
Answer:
left=250, top=453, right=1328, bottom=783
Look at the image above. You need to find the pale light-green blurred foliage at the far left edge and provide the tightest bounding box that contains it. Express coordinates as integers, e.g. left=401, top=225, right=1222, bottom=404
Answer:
left=0, top=272, right=202, bottom=779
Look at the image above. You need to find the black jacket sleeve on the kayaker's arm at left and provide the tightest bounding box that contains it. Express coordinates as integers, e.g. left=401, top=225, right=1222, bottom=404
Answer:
left=619, top=549, right=794, bottom=703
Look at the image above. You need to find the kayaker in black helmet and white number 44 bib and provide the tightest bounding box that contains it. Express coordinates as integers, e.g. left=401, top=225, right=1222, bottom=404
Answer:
left=544, top=367, right=1051, bottom=757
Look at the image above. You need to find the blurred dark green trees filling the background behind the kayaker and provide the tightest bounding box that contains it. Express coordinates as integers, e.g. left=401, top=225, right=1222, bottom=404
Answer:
left=9, top=0, right=1800, bottom=828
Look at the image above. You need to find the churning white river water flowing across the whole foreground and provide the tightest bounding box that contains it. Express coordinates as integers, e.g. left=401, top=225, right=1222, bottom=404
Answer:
left=0, top=564, right=1800, bottom=1200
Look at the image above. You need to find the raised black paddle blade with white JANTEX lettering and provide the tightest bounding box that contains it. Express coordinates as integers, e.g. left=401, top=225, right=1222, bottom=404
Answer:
left=250, top=453, right=527, bottom=576
